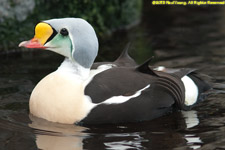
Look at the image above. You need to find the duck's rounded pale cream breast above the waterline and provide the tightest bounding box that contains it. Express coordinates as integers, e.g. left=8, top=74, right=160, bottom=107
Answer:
left=30, top=71, right=94, bottom=124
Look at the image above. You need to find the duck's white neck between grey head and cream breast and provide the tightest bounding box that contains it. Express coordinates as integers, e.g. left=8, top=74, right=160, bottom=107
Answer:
left=57, top=58, right=90, bottom=80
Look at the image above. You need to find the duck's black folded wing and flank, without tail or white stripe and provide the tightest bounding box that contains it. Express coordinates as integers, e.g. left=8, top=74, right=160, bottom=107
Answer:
left=82, top=67, right=184, bottom=124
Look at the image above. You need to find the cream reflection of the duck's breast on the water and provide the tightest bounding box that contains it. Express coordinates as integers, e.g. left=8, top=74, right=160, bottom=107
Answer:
left=29, top=115, right=87, bottom=150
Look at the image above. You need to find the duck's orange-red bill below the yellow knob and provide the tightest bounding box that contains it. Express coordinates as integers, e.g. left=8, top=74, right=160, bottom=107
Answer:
left=19, top=38, right=47, bottom=49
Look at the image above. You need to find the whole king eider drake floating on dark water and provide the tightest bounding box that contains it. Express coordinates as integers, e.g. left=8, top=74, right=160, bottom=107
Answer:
left=19, top=18, right=209, bottom=124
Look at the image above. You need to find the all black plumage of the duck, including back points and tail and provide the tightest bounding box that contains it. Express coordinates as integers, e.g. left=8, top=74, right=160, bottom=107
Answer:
left=80, top=44, right=210, bottom=124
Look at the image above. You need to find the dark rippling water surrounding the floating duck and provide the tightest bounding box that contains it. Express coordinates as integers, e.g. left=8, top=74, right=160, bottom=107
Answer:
left=0, top=0, right=225, bottom=150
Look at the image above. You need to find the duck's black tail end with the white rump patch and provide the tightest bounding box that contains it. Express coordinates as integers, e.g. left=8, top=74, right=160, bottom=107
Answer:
left=154, top=66, right=214, bottom=110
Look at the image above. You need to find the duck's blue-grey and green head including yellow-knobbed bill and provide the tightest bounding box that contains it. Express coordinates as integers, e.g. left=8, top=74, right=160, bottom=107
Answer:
left=19, top=18, right=98, bottom=68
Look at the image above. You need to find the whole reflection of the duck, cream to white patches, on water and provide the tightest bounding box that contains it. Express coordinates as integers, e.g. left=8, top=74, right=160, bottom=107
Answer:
left=29, top=110, right=202, bottom=150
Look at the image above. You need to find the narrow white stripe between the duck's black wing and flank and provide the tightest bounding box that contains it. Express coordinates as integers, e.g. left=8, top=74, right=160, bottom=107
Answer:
left=99, top=84, right=150, bottom=104
